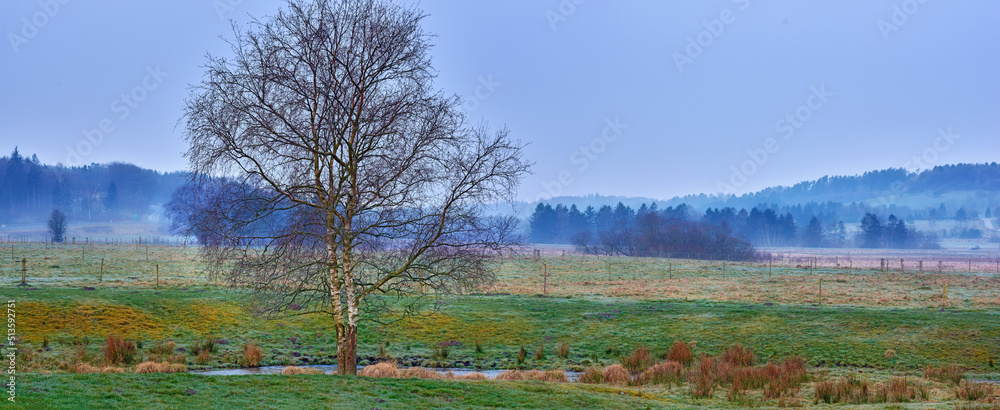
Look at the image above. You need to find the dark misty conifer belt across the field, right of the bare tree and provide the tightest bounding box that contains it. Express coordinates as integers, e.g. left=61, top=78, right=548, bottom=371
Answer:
left=529, top=203, right=940, bottom=251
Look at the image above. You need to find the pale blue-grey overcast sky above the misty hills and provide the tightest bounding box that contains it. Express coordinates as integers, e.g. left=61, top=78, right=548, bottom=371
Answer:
left=0, top=0, right=1000, bottom=200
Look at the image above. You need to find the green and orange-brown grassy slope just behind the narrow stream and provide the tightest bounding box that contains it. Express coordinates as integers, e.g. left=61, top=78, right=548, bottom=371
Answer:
left=4, top=289, right=1000, bottom=372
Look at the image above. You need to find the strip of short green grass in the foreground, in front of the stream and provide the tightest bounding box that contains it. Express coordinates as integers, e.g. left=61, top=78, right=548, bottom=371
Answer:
left=17, top=374, right=684, bottom=409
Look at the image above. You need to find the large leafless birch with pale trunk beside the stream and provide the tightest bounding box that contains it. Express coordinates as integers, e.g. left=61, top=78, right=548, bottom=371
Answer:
left=184, top=0, right=529, bottom=374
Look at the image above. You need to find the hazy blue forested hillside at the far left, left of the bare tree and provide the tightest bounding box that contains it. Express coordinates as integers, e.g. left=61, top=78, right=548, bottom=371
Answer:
left=0, top=148, right=187, bottom=224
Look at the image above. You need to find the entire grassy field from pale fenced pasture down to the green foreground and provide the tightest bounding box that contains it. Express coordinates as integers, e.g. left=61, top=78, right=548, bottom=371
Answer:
left=0, top=244, right=1000, bottom=408
